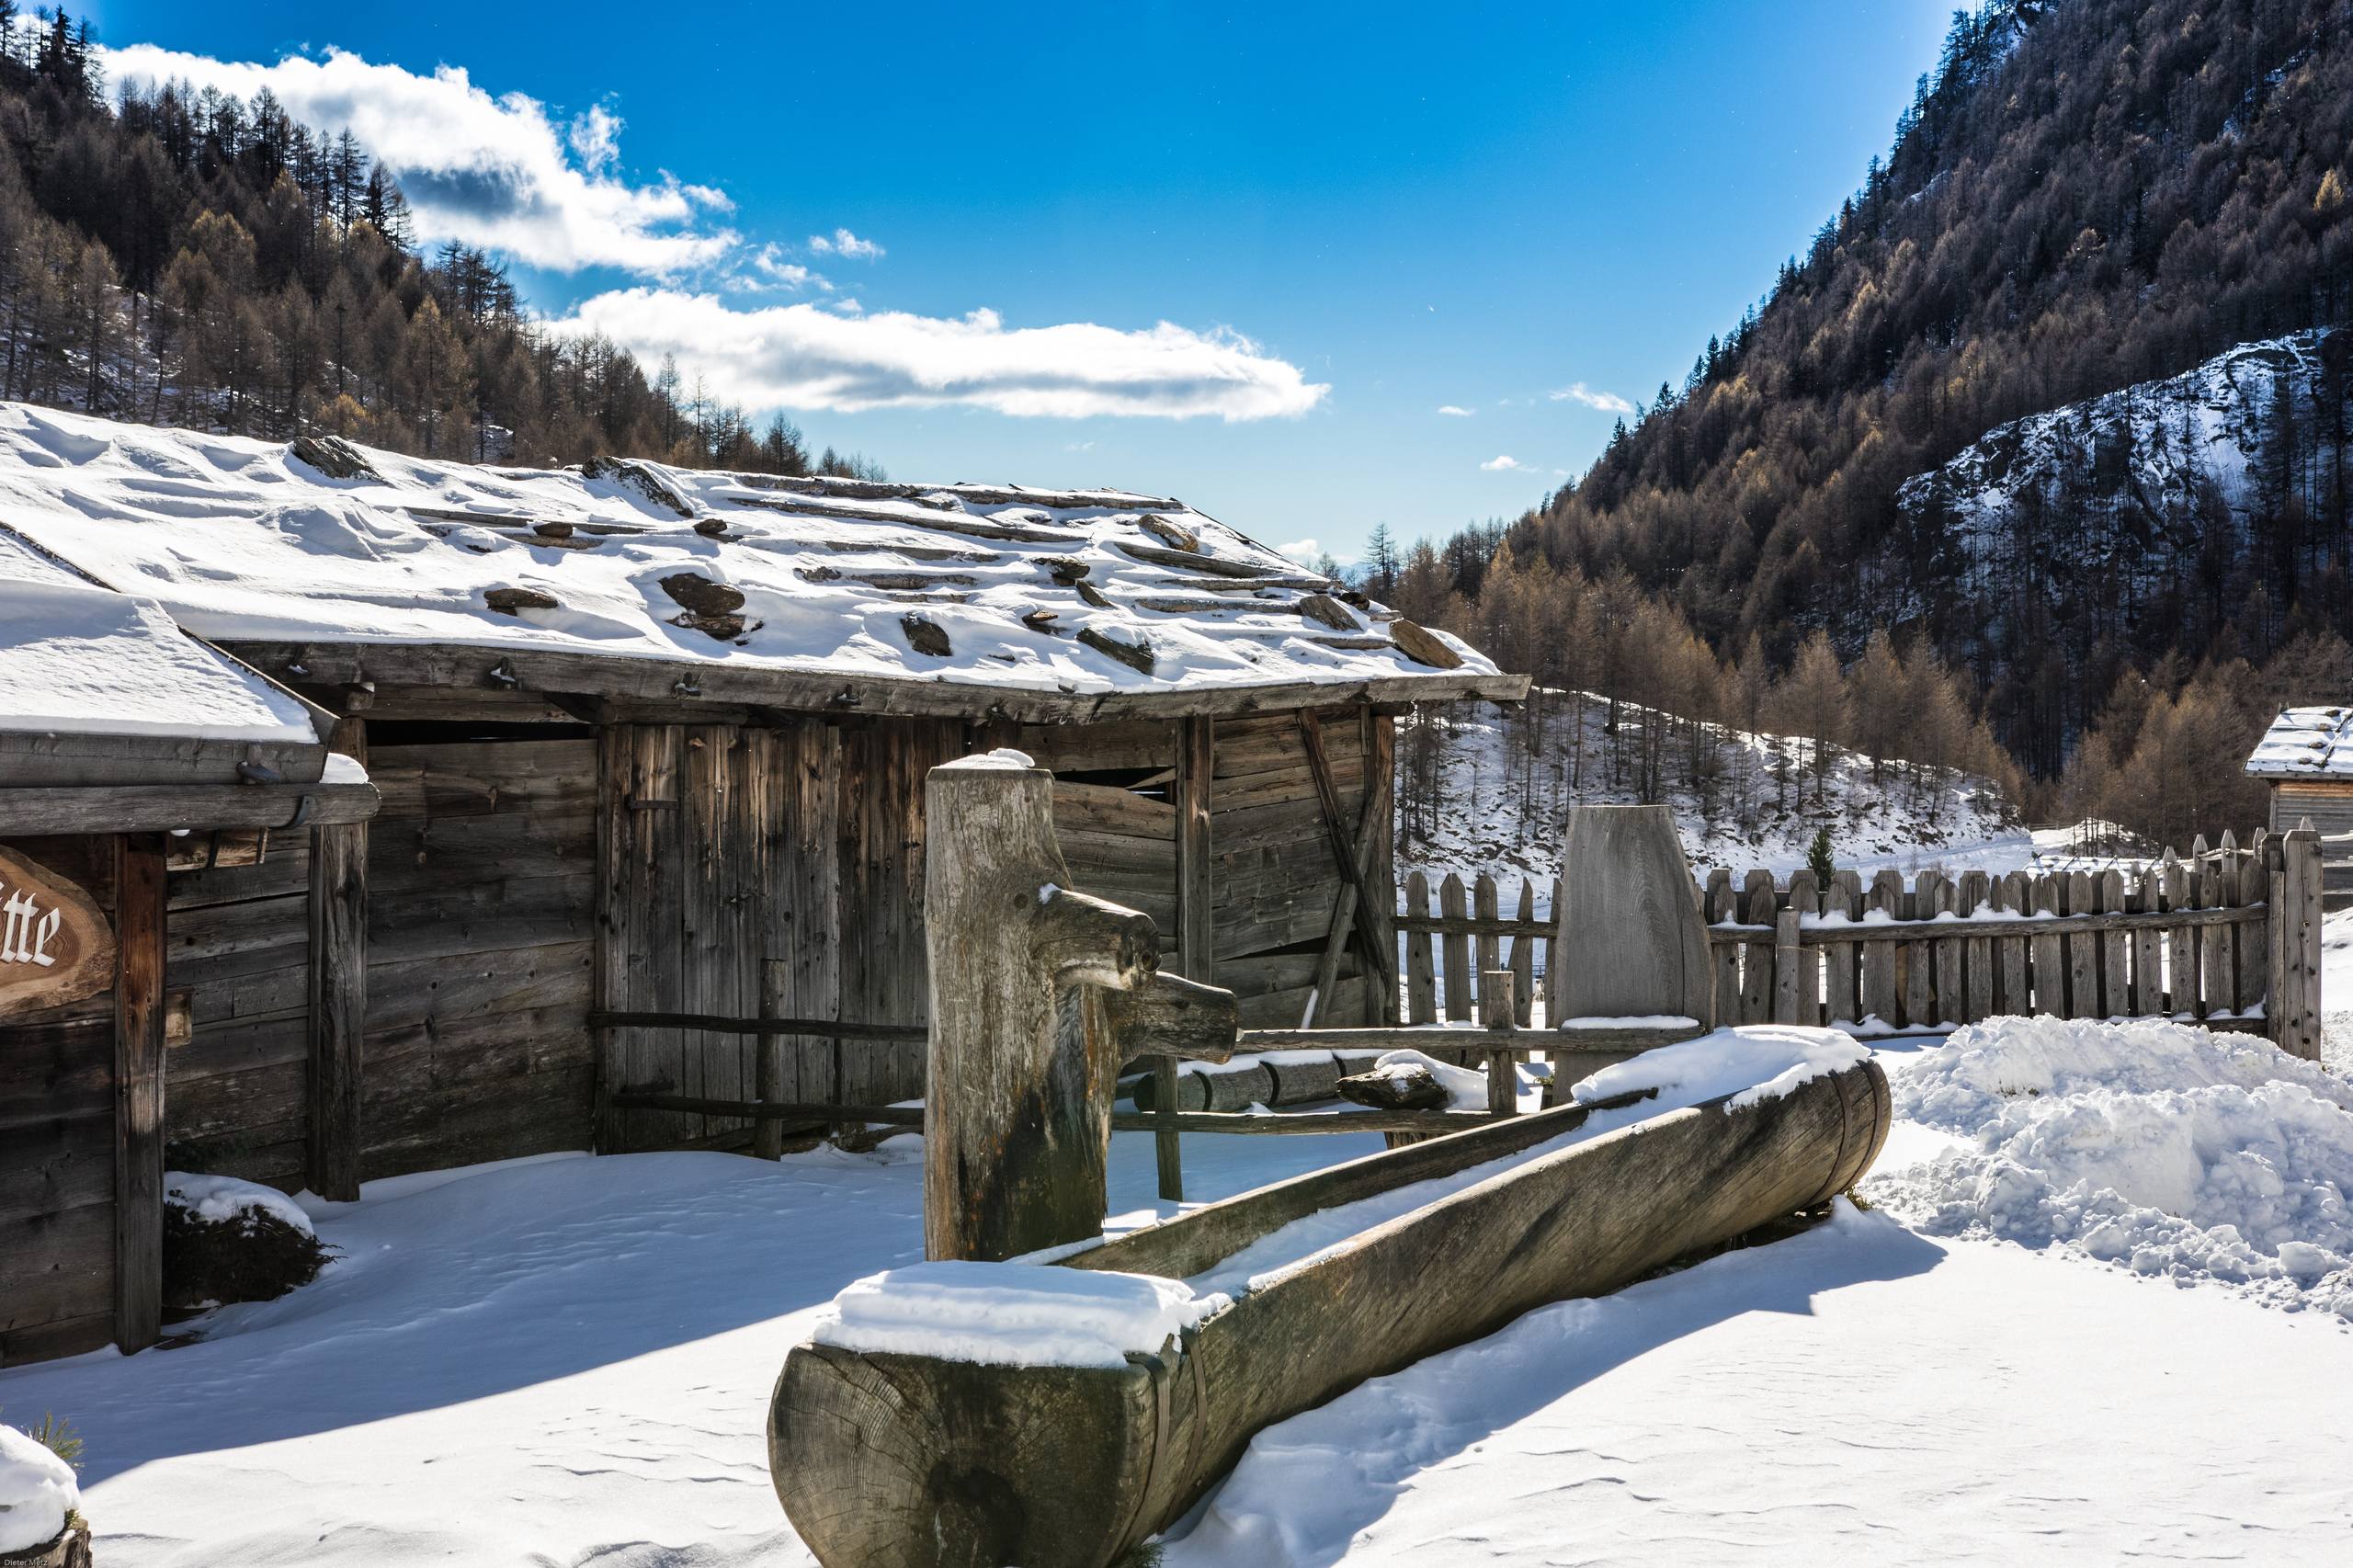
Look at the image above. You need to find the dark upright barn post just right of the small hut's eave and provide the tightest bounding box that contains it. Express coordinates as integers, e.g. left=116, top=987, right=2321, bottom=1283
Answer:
left=303, top=718, right=367, bottom=1203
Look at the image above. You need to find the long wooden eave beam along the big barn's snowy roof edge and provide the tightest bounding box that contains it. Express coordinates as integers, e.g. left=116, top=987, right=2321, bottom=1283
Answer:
left=223, top=641, right=1529, bottom=725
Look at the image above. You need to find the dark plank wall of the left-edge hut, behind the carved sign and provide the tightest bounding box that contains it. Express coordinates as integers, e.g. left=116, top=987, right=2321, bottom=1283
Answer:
left=0, top=838, right=118, bottom=1366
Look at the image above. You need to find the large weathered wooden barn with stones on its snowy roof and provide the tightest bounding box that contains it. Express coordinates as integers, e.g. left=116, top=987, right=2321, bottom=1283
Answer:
left=0, top=405, right=1527, bottom=1290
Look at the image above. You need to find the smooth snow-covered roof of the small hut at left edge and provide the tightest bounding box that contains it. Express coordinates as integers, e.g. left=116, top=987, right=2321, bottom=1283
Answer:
left=0, top=517, right=318, bottom=744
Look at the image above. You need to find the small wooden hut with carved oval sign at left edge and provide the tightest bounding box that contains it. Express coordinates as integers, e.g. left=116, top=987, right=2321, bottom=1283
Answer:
left=0, top=532, right=374, bottom=1363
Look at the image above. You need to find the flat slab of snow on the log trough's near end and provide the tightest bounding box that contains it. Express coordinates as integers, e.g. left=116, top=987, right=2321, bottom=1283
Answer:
left=810, top=1262, right=1226, bottom=1368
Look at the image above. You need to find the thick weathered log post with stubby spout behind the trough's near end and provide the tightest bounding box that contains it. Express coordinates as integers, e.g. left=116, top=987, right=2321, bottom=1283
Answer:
left=923, top=756, right=1174, bottom=1259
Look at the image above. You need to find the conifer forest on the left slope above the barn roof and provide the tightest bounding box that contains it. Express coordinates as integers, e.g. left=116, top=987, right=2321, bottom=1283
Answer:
left=0, top=0, right=878, bottom=475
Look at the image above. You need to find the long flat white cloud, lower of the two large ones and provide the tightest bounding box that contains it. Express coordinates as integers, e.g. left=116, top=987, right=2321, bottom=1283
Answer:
left=551, top=288, right=1329, bottom=422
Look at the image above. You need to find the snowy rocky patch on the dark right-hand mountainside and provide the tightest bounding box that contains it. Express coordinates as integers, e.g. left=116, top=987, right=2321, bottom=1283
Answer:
left=1892, top=330, right=2344, bottom=624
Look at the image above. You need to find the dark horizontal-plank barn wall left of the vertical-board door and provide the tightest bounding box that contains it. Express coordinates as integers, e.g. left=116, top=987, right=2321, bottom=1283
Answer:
left=165, top=737, right=597, bottom=1189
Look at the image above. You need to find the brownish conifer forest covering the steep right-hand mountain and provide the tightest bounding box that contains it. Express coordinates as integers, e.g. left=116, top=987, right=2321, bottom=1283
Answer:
left=1370, top=0, right=2353, bottom=838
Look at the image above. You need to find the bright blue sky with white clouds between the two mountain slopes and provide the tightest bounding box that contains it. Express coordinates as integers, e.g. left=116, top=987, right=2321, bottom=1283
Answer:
left=89, top=0, right=1949, bottom=556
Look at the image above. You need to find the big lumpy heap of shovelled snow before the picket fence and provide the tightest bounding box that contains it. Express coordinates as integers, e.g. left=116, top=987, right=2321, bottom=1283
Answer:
left=1866, top=1017, right=2353, bottom=1318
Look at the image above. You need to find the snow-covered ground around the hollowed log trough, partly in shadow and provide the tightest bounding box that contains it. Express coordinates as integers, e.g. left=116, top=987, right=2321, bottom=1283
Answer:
left=0, top=1007, right=2353, bottom=1568
